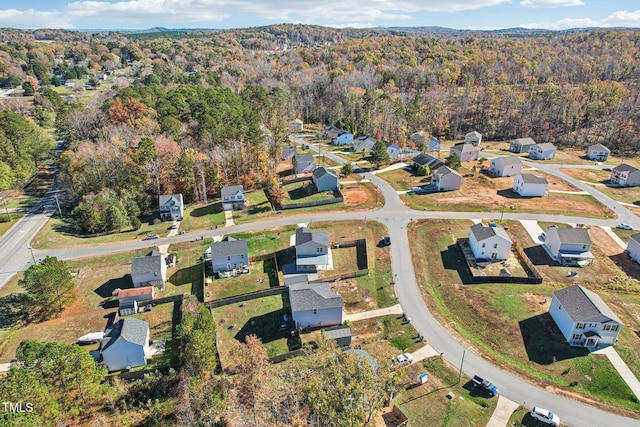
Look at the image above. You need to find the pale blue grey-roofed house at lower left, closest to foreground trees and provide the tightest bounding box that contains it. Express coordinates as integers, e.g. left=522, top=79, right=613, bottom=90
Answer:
left=98, top=317, right=150, bottom=371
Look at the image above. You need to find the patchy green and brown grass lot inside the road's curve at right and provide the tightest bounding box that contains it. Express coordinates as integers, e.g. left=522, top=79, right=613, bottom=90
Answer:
left=408, top=220, right=640, bottom=416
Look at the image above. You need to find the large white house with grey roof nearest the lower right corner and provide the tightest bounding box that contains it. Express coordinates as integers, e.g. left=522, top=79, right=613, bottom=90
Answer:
left=549, top=285, right=624, bottom=349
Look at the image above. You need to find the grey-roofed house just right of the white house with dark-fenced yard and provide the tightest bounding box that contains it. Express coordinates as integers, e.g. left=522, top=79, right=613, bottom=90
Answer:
left=542, top=225, right=594, bottom=266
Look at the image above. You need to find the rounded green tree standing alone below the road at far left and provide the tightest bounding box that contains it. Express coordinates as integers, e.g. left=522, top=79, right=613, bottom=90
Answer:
left=18, top=256, right=75, bottom=319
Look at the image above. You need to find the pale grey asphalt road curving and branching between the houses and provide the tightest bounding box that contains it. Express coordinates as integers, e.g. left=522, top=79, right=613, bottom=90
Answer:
left=0, top=141, right=640, bottom=427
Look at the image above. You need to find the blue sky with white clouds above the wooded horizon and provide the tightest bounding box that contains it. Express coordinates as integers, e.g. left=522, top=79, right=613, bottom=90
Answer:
left=0, top=0, right=640, bottom=30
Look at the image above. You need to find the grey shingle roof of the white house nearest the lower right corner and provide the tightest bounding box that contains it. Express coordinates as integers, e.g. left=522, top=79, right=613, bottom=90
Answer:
left=553, top=285, right=623, bottom=325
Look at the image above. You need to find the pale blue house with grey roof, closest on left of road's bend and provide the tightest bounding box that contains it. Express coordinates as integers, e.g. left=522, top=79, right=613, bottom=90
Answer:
left=289, top=283, right=344, bottom=329
